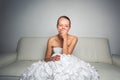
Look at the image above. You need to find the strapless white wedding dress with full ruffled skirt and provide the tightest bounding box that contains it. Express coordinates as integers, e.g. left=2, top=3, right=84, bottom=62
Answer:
left=20, top=47, right=99, bottom=80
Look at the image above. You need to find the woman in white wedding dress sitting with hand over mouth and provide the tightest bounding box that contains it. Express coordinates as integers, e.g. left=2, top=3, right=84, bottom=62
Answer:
left=20, top=16, right=99, bottom=80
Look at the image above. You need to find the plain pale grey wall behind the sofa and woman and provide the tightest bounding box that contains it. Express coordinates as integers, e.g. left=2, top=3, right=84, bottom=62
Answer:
left=0, top=0, right=120, bottom=54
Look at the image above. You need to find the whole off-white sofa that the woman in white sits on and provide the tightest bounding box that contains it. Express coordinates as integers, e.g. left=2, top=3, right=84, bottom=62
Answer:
left=0, top=37, right=120, bottom=80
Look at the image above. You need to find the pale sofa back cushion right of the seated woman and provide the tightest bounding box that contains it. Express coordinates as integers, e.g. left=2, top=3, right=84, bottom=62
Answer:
left=73, top=37, right=112, bottom=64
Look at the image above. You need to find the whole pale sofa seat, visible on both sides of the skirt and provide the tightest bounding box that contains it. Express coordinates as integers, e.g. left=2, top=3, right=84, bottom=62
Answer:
left=0, top=60, right=120, bottom=80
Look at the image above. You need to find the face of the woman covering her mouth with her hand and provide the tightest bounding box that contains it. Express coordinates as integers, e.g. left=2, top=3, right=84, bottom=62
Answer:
left=57, top=18, right=70, bottom=34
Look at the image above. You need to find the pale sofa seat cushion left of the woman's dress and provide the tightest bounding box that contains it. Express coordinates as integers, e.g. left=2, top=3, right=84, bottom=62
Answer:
left=0, top=60, right=35, bottom=77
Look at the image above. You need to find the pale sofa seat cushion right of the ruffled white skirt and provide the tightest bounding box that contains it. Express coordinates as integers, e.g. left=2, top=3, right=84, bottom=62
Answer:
left=91, top=63, right=120, bottom=80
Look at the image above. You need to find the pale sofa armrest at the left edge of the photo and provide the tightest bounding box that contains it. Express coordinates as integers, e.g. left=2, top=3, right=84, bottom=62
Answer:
left=0, top=53, right=17, bottom=67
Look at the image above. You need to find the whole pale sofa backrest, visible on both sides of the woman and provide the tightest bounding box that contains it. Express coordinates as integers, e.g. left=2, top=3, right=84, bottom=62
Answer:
left=18, top=37, right=112, bottom=63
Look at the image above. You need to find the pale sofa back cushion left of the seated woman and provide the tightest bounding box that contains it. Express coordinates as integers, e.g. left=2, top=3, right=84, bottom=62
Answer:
left=18, top=37, right=48, bottom=60
